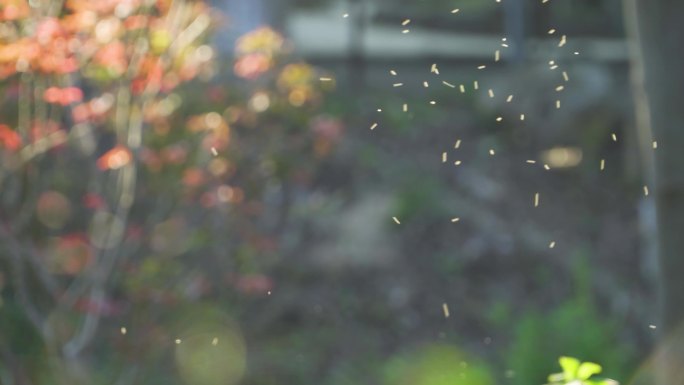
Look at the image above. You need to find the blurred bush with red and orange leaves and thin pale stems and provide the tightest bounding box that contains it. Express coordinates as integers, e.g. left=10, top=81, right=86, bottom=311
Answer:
left=0, top=0, right=344, bottom=378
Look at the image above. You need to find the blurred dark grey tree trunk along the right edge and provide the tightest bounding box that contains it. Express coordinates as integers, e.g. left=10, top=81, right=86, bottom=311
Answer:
left=624, top=0, right=684, bottom=385
